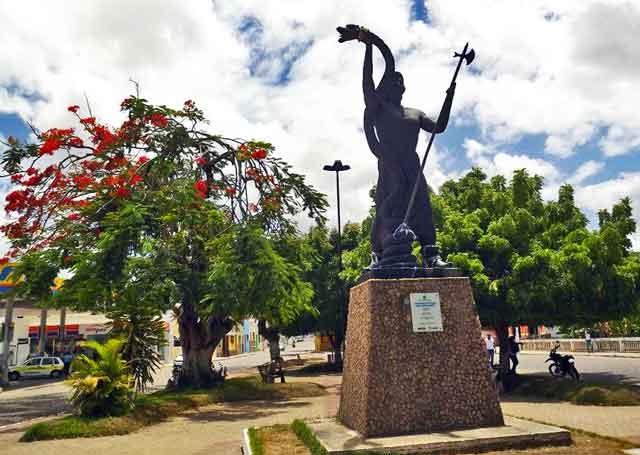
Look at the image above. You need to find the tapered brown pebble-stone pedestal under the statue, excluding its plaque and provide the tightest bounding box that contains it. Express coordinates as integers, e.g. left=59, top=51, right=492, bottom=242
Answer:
left=339, top=277, right=504, bottom=437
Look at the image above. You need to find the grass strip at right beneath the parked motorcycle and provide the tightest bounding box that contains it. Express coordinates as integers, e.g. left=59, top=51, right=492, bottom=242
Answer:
left=515, top=375, right=640, bottom=406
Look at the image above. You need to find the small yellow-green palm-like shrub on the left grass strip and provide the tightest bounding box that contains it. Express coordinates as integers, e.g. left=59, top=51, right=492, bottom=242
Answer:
left=67, top=338, right=133, bottom=417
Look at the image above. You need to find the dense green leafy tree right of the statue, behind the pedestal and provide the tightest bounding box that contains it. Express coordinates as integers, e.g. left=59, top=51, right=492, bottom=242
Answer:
left=434, top=169, right=640, bottom=372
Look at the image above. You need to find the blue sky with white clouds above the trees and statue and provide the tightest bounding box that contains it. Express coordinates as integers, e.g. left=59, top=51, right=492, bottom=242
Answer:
left=0, top=0, right=640, bottom=246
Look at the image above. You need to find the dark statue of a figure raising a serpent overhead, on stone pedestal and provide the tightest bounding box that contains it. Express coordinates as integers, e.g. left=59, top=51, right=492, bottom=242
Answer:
left=338, top=24, right=462, bottom=268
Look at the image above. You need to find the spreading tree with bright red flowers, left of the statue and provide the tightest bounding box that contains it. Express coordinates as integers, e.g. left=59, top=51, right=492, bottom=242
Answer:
left=1, top=96, right=326, bottom=386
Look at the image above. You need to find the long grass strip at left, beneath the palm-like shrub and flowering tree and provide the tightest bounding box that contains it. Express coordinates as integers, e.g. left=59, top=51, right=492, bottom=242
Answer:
left=20, top=376, right=326, bottom=442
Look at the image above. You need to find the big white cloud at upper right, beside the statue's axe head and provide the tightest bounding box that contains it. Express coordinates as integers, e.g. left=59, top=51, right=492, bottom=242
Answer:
left=430, top=0, right=640, bottom=158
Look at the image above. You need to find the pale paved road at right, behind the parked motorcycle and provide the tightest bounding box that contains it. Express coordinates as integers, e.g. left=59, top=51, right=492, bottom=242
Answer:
left=518, top=353, right=640, bottom=385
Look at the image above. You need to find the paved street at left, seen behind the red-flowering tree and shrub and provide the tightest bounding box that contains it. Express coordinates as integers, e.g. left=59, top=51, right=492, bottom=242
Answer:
left=0, top=338, right=313, bottom=429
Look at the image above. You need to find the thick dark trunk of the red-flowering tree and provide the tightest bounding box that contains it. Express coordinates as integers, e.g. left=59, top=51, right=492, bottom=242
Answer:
left=178, top=303, right=233, bottom=388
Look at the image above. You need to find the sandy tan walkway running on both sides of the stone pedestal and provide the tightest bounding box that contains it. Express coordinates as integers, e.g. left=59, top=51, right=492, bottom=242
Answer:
left=0, top=375, right=640, bottom=455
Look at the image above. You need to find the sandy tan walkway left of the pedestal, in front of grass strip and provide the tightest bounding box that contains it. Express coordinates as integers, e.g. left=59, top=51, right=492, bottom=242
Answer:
left=0, top=375, right=340, bottom=455
